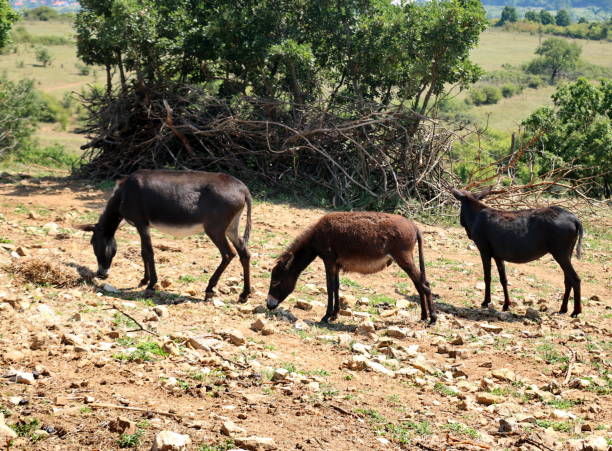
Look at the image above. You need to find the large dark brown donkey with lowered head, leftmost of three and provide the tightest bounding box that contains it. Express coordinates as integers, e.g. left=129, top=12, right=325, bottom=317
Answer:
left=79, top=170, right=252, bottom=302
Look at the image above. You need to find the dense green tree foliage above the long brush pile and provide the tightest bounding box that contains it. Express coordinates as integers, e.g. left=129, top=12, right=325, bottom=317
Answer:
left=76, top=0, right=486, bottom=113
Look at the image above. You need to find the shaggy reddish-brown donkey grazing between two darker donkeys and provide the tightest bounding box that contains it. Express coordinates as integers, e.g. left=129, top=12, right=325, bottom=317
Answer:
left=266, top=212, right=436, bottom=324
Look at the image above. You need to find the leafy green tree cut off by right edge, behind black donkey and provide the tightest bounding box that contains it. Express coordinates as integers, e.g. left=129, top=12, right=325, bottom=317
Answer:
left=523, top=78, right=612, bottom=197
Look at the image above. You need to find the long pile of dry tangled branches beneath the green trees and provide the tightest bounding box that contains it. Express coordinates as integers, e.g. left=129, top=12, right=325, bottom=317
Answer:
left=79, top=86, right=462, bottom=211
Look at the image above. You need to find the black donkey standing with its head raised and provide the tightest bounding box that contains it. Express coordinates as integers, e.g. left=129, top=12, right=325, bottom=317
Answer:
left=452, top=189, right=584, bottom=318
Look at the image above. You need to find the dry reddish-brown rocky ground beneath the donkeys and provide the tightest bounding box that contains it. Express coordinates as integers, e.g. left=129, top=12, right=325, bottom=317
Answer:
left=0, top=174, right=612, bottom=451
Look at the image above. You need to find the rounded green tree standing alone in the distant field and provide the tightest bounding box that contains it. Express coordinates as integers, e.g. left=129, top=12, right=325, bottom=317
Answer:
left=526, top=38, right=582, bottom=84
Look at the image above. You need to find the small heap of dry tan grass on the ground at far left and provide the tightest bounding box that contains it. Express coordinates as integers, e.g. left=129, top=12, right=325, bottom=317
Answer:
left=5, top=257, right=93, bottom=288
